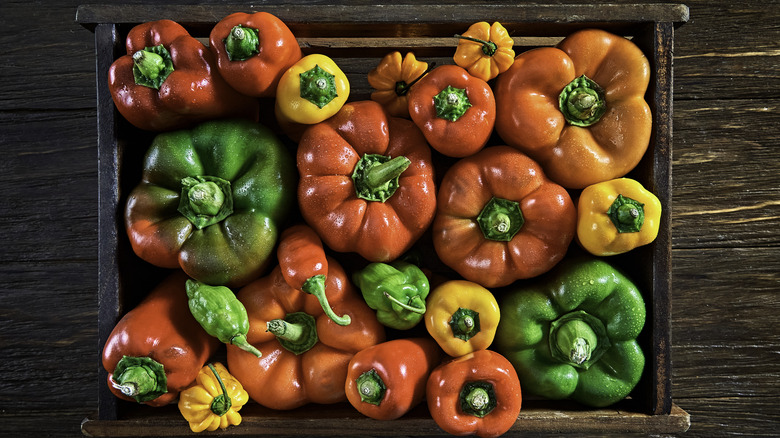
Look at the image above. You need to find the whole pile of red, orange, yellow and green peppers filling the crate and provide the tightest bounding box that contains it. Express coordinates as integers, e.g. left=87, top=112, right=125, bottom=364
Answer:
left=102, top=12, right=662, bottom=437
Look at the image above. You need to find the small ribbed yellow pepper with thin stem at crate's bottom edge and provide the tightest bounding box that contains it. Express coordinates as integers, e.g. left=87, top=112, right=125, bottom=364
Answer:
left=179, top=362, right=249, bottom=432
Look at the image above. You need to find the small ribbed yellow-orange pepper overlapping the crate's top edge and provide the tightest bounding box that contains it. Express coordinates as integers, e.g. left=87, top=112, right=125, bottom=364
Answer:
left=452, top=21, right=515, bottom=82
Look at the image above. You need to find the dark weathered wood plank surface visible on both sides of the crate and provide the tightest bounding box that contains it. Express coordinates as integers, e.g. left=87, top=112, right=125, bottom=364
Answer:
left=0, top=0, right=780, bottom=437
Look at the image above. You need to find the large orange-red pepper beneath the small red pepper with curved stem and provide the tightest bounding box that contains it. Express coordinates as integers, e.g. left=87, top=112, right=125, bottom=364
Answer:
left=227, top=259, right=385, bottom=409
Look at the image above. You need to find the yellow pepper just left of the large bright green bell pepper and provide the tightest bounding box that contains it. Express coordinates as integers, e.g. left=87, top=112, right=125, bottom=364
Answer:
left=425, top=280, right=501, bottom=357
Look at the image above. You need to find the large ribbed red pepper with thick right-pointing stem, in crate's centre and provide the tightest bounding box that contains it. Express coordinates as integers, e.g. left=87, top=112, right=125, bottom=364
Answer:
left=298, top=100, right=436, bottom=262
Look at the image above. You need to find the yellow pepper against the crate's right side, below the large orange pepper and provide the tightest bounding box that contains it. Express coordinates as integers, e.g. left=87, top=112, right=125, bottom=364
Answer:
left=577, top=178, right=661, bottom=256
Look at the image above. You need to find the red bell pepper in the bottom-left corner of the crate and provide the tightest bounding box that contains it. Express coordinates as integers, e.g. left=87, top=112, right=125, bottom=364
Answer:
left=102, top=271, right=219, bottom=406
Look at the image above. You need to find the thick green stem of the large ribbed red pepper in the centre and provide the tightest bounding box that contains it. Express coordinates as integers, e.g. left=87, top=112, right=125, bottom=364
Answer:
left=352, top=154, right=412, bottom=202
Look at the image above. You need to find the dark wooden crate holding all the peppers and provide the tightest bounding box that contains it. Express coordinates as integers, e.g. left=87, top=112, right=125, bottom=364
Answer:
left=77, top=2, right=690, bottom=436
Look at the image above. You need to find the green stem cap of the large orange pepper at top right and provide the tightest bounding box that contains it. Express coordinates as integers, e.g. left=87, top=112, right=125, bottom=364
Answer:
left=558, top=75, right=607, bottom=127
